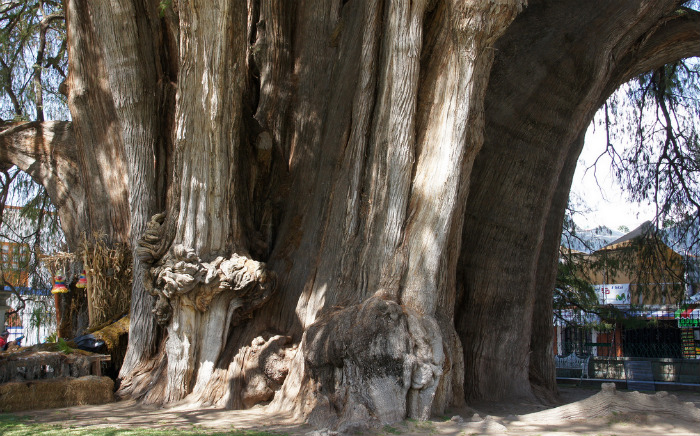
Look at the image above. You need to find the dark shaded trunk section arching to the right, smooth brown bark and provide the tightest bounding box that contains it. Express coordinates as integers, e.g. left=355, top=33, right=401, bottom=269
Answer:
left=457, top=1, right=697, bottom=400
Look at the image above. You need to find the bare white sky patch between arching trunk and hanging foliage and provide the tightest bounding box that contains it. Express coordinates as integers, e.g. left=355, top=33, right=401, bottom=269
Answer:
left=571, top=123, right=655, bottom=230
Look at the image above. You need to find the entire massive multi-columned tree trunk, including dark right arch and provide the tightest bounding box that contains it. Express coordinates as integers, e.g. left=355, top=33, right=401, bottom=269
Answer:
left=0, top=0, right=700, bottom=429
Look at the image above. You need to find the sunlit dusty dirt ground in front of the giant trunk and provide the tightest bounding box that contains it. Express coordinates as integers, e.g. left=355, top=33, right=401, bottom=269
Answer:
left=18, top=385, right=700, bottom=436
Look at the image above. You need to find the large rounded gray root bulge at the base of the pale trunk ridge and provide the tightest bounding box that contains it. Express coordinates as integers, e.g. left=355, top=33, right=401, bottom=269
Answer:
left=274, top=297, right=444, bottom=432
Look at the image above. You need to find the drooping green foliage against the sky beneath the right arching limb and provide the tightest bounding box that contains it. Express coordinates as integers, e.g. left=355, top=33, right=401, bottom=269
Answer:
left=598, top=58, right=700, bottom=252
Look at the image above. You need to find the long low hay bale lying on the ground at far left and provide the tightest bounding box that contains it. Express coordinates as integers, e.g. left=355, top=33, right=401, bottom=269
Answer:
left=0, top=375, right=114, bottom=412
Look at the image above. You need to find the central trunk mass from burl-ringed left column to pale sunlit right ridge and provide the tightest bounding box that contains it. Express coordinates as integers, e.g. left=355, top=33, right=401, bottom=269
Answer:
left=117, top=1, right=520, bottom=425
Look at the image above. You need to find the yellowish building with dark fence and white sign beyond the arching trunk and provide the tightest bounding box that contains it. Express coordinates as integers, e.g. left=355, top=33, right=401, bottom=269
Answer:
left=554, top=222, right=700, bottom=359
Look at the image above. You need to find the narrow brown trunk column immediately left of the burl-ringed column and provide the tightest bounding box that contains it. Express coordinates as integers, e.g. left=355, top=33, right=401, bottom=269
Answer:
left=76, top=1, right=172, bottom=382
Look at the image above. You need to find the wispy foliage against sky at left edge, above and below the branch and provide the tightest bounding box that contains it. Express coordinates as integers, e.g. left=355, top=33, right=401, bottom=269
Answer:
left=0, top=0, right=69, bottom=314
